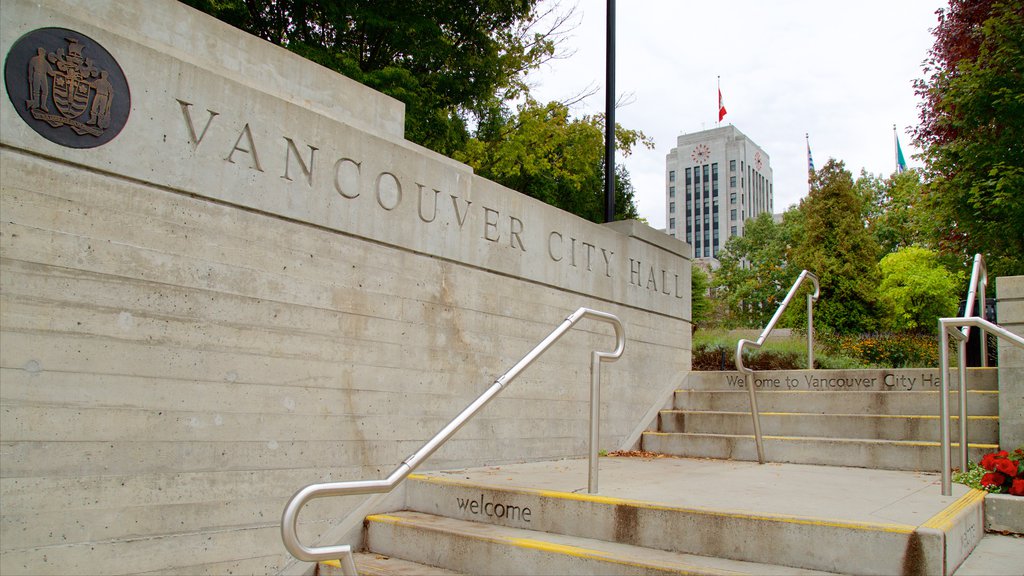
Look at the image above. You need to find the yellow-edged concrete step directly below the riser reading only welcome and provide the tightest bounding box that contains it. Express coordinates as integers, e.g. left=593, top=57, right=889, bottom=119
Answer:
left=367, top=510, right=828, bottom=575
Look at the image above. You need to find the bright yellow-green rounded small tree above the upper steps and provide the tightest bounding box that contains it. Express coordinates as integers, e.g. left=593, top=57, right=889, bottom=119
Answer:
left=879, top=246, right=964, bottom=333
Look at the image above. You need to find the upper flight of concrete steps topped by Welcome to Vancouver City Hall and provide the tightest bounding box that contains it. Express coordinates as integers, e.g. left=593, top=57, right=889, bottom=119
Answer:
left=641, top=369, right=998, bottom=471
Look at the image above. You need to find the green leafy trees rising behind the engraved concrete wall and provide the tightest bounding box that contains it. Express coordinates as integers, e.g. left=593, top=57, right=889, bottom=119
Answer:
left=183, top=0, right=652, bottom=221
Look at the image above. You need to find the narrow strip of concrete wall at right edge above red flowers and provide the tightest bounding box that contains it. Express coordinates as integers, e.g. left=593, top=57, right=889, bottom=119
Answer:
left=995, top=276, right=1024, bottom=450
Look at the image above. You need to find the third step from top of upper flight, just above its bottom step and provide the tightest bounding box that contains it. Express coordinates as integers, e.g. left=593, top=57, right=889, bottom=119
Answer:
left=658, top=410, right=999, bottom=444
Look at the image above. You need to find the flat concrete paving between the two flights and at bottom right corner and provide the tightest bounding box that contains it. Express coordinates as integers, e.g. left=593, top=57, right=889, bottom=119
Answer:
left=424, top=457, right=1024, bottom=575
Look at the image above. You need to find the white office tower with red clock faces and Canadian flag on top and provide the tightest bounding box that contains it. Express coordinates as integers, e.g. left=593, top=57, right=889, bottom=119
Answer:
left=665, top=125, right=773, bottom=268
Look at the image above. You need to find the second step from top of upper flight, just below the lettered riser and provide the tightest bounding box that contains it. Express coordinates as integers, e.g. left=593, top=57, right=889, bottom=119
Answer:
left=673, top=389, right=999, bottom=416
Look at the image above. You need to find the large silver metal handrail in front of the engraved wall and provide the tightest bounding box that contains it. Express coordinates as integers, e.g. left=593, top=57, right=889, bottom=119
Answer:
left=281, top=307, right=626, bottom=565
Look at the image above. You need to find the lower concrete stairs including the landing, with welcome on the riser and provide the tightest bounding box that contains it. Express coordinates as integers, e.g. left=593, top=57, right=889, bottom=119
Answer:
left=321, top=458, right=999, bottom=575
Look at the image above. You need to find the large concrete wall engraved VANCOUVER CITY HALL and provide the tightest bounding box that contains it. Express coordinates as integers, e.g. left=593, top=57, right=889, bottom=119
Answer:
left=0, top=0, right=690, bottom=574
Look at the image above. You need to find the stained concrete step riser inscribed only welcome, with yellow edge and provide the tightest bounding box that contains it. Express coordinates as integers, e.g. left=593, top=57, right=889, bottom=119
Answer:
left=403, top=469, right=946, bottom=574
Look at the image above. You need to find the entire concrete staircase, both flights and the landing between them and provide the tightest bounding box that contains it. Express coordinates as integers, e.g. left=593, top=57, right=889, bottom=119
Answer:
left=318, top=370, right=1024, bottom=575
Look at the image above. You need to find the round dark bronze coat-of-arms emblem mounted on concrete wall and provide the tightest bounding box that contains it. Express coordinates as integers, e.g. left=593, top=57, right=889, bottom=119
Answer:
left=4, top=28, right=131, bottom=149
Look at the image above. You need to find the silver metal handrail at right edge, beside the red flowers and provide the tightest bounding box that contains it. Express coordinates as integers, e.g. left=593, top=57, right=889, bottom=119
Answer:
left=939, top=316, right=1024, bottom=496
